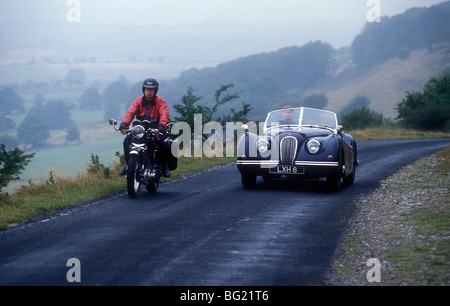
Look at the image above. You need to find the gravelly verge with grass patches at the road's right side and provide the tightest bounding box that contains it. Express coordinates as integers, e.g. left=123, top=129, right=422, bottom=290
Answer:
left=330, top=147, right=450, bottom=286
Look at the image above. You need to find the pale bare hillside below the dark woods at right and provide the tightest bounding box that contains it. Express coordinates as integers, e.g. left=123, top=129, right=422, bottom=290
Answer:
left=305, top=44, right=450, bottom=119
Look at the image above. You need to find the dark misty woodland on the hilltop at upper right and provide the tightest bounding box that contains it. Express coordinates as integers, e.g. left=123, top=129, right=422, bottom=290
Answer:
left=351, top=2, right=450, bottom=68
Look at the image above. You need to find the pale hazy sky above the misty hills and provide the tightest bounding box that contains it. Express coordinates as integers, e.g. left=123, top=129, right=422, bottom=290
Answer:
left=0, top=0, right=448, bottom=78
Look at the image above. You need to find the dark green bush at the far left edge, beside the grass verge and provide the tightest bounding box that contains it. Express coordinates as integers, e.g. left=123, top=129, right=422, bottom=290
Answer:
left=0, top=144, right=35, bottom=195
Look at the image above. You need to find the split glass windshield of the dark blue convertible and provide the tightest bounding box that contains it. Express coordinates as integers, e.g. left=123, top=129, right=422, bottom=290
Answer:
left=265, top=107, right=337, bottom=131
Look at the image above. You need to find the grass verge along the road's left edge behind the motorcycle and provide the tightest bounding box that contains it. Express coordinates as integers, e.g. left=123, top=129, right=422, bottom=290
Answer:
left=0, top=157, right=235, bottom=230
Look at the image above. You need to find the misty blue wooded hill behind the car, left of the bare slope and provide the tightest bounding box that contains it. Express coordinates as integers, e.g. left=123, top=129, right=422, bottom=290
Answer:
left=161, top=41, right=335, bottom=119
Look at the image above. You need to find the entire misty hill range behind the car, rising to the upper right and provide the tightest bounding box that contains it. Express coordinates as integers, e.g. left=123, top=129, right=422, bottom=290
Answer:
left=164, top=2, right=450, bottom=120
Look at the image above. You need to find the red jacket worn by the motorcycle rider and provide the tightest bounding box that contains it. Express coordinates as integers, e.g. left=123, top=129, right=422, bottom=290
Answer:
left=122, top=96, right=169, bottom=127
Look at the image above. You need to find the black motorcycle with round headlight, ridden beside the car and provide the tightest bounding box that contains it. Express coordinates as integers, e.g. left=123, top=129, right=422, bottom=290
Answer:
left=109, top=119, right=179, bottom=198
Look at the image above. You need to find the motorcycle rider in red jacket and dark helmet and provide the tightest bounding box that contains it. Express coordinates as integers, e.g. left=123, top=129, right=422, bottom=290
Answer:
left=119, top=78, right=170, bottom=177
